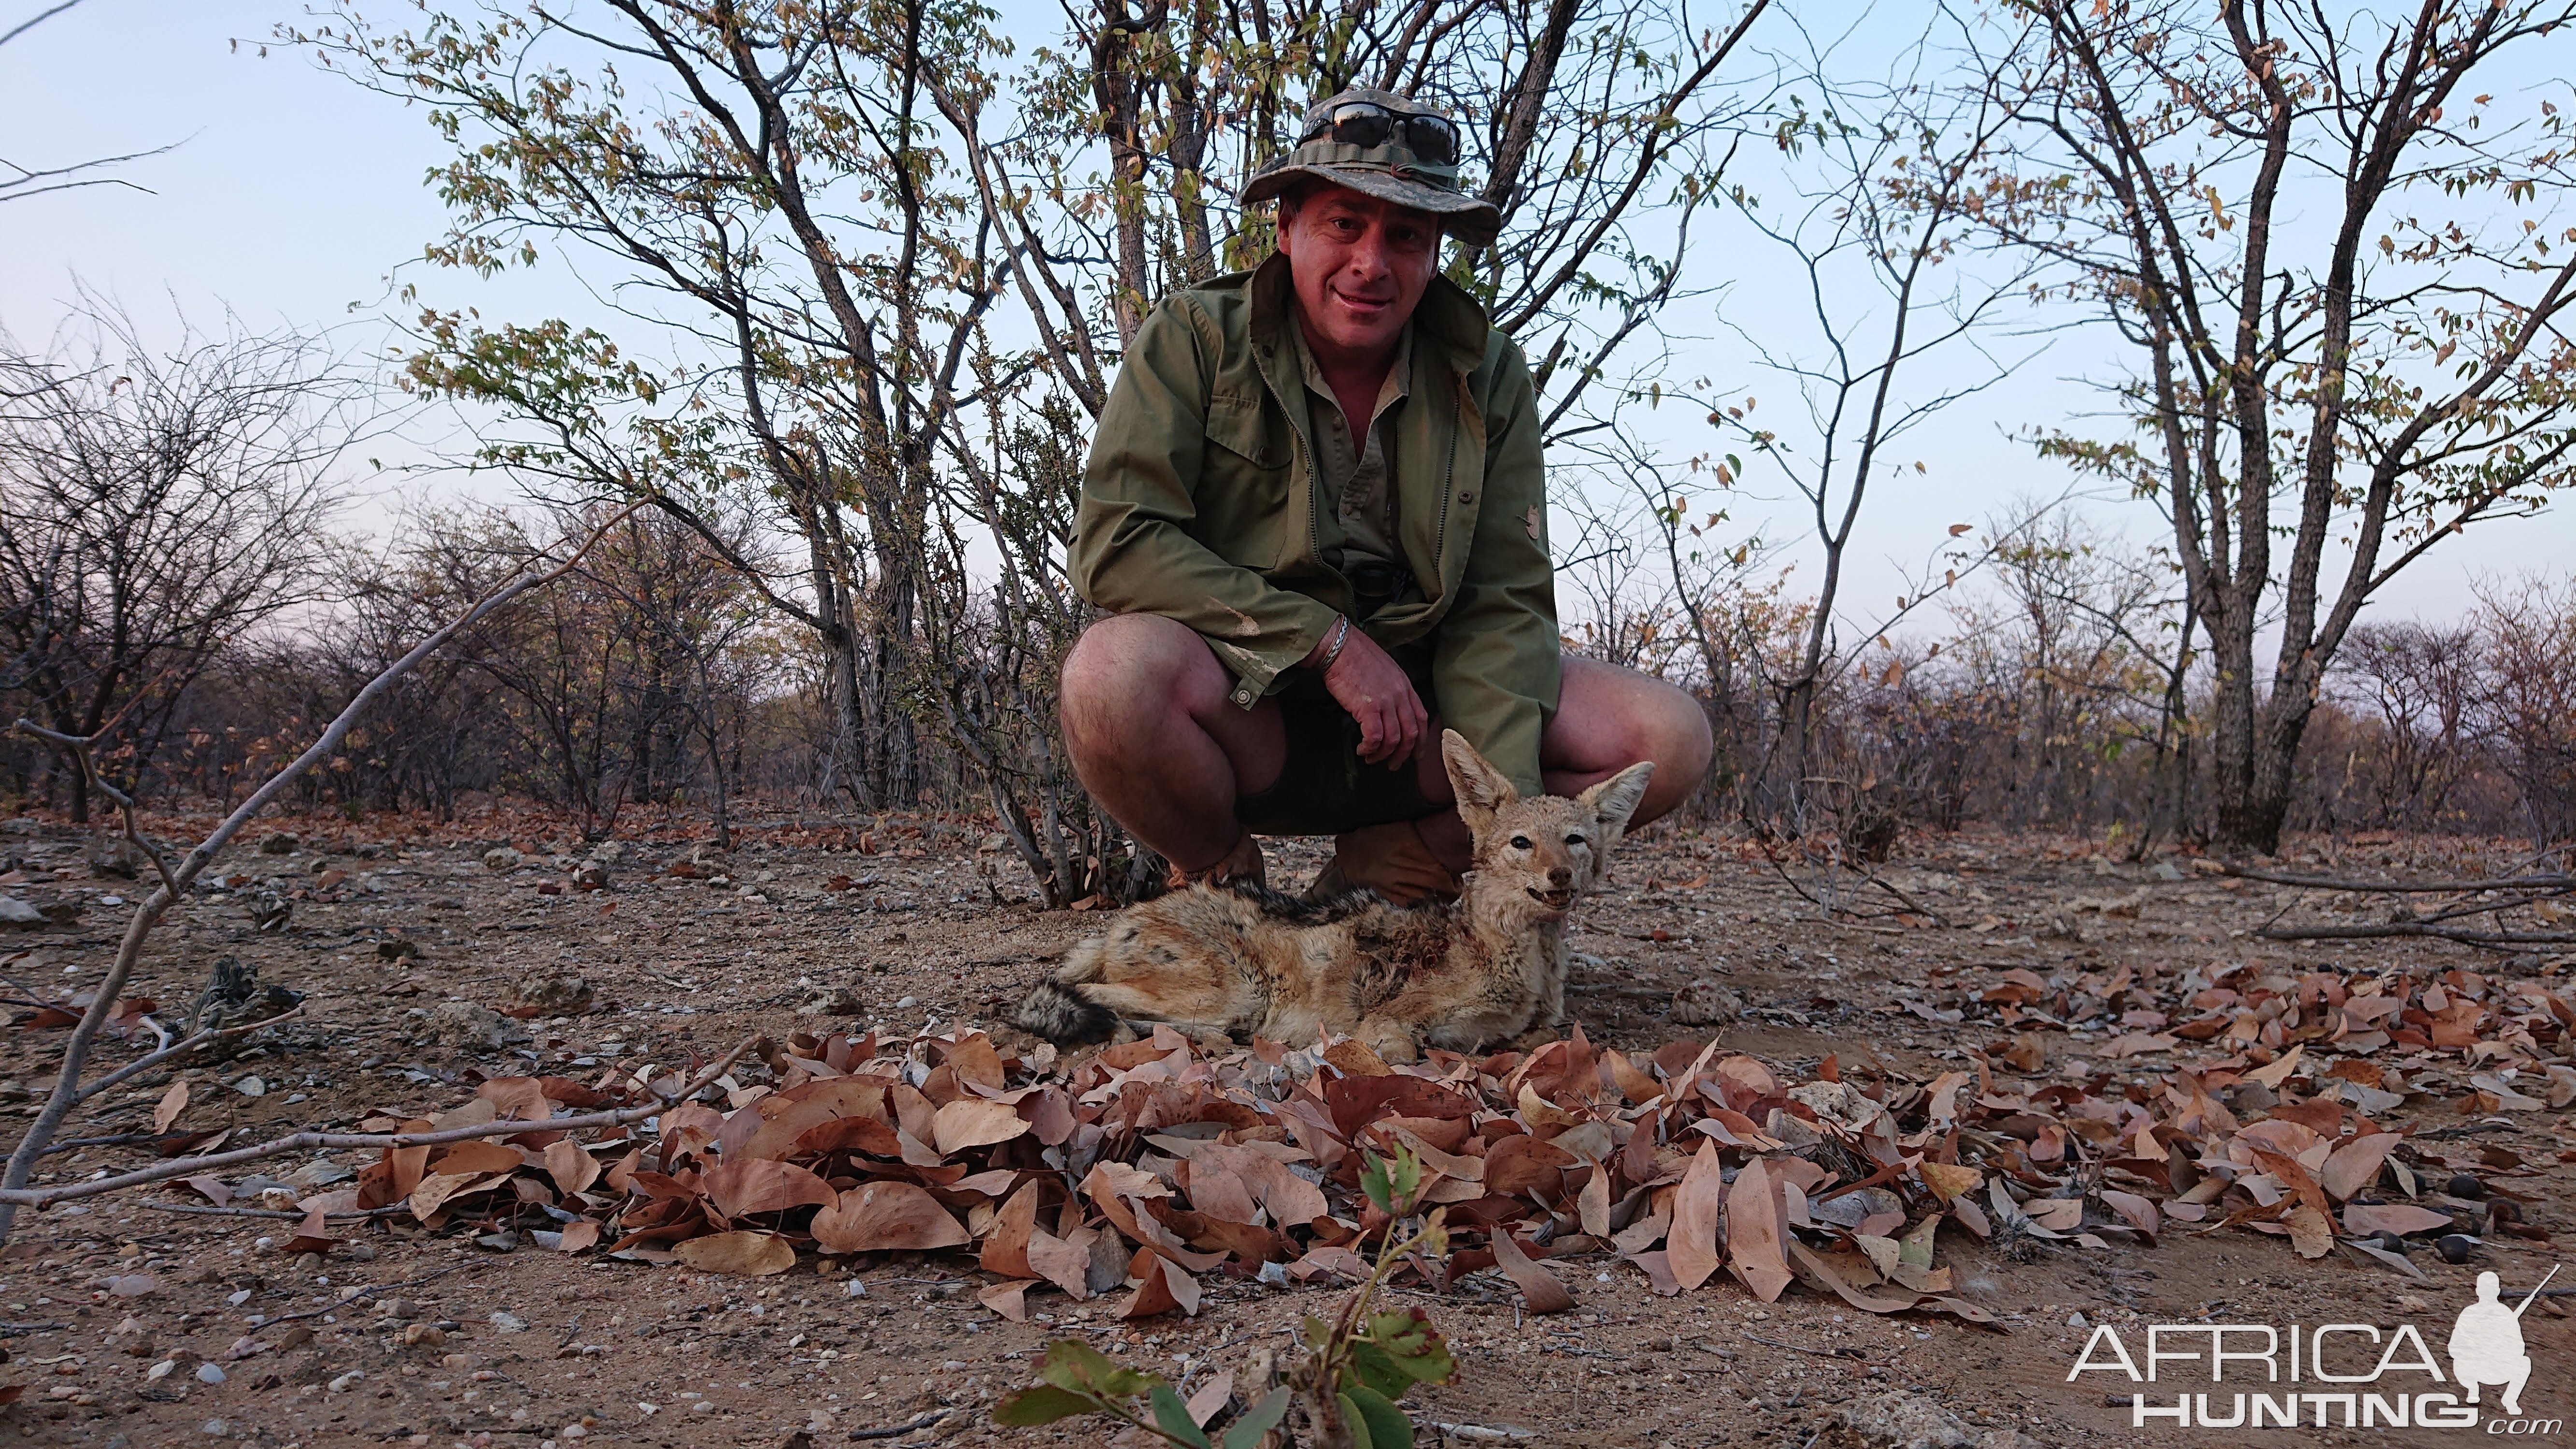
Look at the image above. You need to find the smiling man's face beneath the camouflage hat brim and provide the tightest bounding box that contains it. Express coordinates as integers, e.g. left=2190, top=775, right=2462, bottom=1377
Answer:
left=1278, top=185, right=1440, bottom=360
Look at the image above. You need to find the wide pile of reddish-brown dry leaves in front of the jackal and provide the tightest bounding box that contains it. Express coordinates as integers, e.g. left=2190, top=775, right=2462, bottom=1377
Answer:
left=166, top=952, right=2576, bottom=1323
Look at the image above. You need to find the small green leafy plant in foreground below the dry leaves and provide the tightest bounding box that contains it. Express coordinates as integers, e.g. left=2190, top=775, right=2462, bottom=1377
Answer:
left=995, top=1148, right=1458, bottom=1449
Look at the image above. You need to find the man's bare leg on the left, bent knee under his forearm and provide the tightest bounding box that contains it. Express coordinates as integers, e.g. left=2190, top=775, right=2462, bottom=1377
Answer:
left=1061, top=612, right=1288, bottom=875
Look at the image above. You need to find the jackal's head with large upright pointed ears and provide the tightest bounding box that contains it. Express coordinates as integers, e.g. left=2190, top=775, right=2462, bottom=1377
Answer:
left=1440, top=728, right=1654, bottom=924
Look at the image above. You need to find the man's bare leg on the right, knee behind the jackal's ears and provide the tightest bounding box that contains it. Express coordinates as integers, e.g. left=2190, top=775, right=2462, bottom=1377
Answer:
left=1411, top=653, right=1716, bottom=872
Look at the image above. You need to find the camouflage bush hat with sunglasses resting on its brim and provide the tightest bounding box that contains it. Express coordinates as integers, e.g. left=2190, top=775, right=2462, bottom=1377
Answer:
left=1242, top=87, right=1502, bottom=247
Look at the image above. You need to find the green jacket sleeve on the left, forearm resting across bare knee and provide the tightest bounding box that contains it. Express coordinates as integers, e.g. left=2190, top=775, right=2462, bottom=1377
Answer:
left=1067, top=298, right=1337, bottom=708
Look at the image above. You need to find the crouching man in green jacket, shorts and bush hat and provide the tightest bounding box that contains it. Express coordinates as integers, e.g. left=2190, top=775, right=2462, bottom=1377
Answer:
left=1064, top=90, right=1710, bottom=901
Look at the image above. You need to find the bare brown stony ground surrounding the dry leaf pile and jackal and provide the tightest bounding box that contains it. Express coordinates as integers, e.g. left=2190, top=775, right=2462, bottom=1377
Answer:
left=0, top=813, right=2576, bottom=1449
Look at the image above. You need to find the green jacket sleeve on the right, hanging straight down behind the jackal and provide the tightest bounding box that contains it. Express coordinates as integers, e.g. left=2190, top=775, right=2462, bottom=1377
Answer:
left=1432, top=347, right=1564, bottom=796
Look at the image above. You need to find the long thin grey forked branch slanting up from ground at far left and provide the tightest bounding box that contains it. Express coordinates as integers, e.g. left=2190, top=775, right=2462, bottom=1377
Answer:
left=0, top=504, right=641, bottom=1243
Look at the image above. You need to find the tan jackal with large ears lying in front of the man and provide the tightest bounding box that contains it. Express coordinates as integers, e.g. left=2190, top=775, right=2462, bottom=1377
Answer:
left=1010, top=731, right=1654, bottom=1060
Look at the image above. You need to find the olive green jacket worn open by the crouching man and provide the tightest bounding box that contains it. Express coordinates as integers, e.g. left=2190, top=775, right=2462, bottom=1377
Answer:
left=1069, top=255, right=1558, bottom=793
